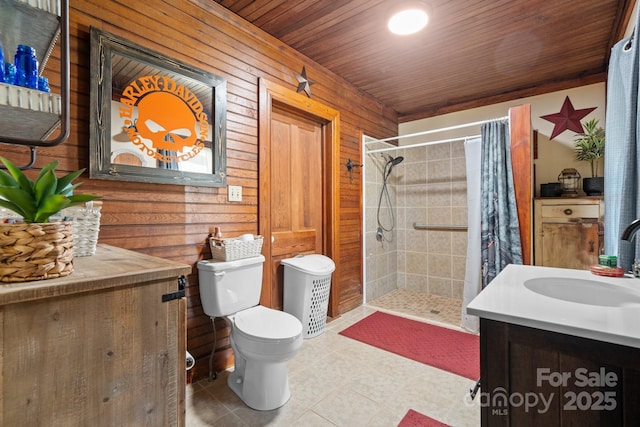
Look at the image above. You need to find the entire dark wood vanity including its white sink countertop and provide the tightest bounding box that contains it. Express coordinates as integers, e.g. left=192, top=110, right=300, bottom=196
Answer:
left=467, top=264, right=640, bottom=427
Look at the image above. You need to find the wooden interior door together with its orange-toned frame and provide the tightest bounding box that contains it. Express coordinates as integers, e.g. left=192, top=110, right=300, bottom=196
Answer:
left=258, top=78, right=342, bottom=317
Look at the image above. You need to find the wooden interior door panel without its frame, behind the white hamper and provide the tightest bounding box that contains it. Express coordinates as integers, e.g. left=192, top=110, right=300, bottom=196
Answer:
left=267, top=109, right=324, bottom=309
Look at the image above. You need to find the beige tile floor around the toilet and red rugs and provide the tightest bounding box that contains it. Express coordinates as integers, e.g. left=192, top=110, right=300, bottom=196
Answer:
left=186, top=295, right=480, bottom=427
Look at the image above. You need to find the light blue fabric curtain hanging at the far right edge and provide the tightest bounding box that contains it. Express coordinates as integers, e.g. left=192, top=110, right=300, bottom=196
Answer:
left=604, top=19, right=640, bottom=271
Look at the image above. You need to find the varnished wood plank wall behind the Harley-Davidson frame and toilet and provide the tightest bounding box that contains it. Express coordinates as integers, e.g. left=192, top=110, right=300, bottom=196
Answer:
left=0, top=0, right=398, bottom=379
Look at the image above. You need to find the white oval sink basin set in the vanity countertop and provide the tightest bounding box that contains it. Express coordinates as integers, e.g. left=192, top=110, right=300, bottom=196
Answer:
left=524, top=277, right=640, bottom=307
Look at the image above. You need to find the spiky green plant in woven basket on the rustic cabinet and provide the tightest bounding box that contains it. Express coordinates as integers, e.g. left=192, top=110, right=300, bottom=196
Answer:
left=0, top=157, right=98, bottom=282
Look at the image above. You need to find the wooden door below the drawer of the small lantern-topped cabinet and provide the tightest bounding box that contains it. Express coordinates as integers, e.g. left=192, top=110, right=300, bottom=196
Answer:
left=541, top=221, right=600, bottom=270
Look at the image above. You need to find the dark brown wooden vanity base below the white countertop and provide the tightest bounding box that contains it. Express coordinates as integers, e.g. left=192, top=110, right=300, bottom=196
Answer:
left=476, top=318, right=640, bottom=427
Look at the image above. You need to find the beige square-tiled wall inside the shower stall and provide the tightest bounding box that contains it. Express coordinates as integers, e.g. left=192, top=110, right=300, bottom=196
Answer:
left=365, top=141, right=467, bottom=301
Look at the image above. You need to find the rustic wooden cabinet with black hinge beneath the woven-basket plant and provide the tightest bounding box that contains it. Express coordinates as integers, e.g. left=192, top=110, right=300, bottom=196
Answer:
left=0, top=244, right=191, bottom=427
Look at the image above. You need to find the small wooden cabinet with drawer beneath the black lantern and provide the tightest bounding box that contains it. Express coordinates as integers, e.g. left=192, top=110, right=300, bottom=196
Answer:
left=534, top=197, right=604, bottom=270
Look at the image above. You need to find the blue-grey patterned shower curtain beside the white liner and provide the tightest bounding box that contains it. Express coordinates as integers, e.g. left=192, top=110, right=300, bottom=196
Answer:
left=480, top=120, right=522, bottom=289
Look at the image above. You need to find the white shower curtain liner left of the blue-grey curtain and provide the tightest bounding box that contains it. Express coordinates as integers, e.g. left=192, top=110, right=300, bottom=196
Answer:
left=461, top=138, right=482, bottom=332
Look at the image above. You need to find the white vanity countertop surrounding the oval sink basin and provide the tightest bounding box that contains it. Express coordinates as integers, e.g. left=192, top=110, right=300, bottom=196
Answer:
left=467, top=265, right=640, bottom=348
